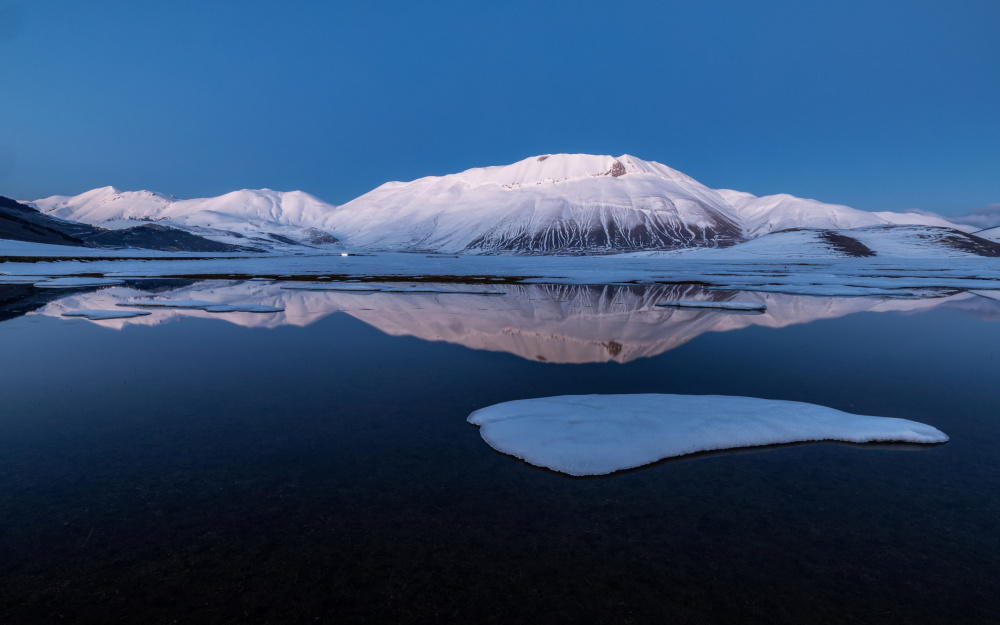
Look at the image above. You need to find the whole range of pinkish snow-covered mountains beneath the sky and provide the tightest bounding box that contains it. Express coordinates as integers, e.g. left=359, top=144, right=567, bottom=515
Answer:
left=25, top=154, right=975, bottom=254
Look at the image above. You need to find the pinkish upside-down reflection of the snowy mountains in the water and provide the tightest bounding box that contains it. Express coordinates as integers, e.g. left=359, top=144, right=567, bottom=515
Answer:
left=25, top=281, right=1000, bottom=363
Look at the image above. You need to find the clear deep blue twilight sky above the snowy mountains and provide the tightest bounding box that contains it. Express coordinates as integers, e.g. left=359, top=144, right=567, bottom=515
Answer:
left=0, top=0, right=1000, bottom=213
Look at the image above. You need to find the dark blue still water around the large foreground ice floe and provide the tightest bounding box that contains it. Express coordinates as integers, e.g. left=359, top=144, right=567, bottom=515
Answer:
left=0, top=284, right=1000, bottom=623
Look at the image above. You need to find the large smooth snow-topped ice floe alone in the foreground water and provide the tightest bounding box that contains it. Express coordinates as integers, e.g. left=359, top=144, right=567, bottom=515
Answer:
left=468, top=394, right=948, bottom=475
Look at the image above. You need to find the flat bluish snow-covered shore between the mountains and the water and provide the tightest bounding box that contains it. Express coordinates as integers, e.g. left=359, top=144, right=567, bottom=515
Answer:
left=0, top=241, right=1000, bottom=297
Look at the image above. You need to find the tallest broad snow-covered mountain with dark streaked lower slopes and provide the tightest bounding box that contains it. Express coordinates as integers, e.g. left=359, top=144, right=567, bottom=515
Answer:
left=325, top=154, right=743, bottom=254
